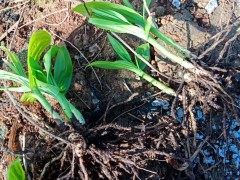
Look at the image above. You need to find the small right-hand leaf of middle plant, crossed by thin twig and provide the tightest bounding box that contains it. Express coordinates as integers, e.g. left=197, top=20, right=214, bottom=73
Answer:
left=135, top=43, right=150, bottom=70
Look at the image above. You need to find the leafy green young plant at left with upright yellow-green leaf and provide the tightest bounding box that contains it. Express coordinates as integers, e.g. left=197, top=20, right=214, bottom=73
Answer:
left=0, top=30, right=85, bottom=125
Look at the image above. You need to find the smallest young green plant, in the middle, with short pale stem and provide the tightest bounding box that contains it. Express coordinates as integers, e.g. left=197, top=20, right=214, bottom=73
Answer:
left=88, top=34, right=176, bottom=96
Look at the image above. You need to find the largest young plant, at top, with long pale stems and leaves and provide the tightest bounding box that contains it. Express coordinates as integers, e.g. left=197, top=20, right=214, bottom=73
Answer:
left=73, top=0, right=205, bottom=75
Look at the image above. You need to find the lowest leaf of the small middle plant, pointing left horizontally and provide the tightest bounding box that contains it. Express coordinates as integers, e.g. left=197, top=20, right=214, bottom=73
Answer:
left=88, top=61, right=138, bottom=72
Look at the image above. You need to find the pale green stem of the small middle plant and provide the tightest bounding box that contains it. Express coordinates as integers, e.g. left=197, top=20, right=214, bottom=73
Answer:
left=135, top=70, right=176, bottom=96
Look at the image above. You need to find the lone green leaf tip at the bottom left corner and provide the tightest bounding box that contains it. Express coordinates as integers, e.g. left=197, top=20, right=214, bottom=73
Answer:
left=7, top=158, right=26, bottom=180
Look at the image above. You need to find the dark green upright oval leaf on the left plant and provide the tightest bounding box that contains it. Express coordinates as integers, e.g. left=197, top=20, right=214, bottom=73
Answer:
left=53, top=46, right=73, bottom=94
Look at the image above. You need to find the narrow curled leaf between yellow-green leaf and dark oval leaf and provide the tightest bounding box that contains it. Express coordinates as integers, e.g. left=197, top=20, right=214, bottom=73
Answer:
left=43, top=45, right=59, bottom=85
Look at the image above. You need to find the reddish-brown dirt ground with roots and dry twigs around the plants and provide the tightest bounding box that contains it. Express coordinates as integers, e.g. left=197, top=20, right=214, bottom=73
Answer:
left=0, top=0, right=240, bottom=180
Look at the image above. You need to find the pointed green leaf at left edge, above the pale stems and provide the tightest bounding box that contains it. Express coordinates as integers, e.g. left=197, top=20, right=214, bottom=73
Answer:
left=0, top=46, right=27, bottom=77
